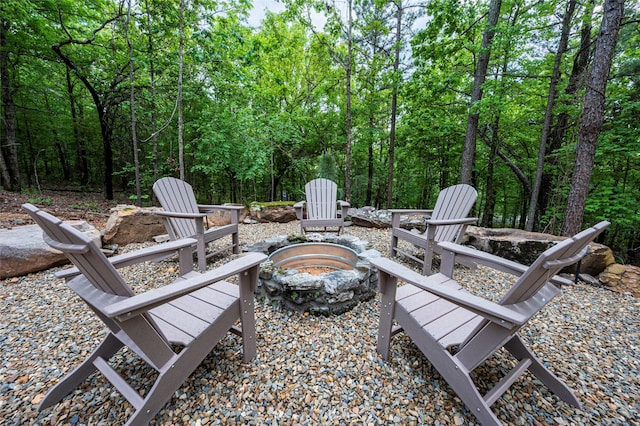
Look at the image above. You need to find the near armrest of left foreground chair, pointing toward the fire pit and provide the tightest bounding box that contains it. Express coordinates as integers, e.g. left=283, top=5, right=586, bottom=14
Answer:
left=103, top=253, right=267, bottom=321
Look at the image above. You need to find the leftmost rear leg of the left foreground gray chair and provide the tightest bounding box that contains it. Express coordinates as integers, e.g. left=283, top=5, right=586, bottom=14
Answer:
left=38, top=333, right=124, bottom=411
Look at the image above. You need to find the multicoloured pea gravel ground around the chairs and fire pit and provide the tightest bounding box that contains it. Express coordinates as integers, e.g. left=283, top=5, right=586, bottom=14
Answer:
left=0, top=223, right=640, bottom=425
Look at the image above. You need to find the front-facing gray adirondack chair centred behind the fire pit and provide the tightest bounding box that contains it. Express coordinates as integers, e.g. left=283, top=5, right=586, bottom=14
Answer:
left=293, top=178, right=350, bottom=234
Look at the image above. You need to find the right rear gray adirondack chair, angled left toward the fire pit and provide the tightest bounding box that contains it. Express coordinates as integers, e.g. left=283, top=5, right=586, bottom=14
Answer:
left=390, top=184, right=478, bottom=275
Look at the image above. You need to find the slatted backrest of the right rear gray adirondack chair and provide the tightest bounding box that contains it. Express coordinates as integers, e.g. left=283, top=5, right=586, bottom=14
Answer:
left=431, top=184, right=478, bottom=243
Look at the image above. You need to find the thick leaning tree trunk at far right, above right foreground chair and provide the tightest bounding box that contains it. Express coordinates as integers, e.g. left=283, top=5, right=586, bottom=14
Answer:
left=562, top=0, right=624, bottom=236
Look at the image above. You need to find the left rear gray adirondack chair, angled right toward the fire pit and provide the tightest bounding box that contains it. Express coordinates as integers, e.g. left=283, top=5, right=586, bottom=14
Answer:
left=153, top=177, right=242, bottom=271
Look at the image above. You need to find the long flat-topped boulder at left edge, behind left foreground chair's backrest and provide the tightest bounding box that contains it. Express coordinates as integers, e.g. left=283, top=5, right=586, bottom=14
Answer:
left=0, top=220, right=102, bottom=279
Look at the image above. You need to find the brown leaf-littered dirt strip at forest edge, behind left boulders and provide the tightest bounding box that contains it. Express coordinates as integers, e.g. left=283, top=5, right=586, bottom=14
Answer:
left=0, top=190, right=131, bottom=230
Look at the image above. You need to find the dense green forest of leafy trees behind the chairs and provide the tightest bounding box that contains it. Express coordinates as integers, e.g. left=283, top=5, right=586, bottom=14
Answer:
left=0, top=0, right=640, bottom=264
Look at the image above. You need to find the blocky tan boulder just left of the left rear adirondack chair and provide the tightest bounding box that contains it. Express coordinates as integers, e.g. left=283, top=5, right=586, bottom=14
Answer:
left=102, top=204, right=167, bottom=245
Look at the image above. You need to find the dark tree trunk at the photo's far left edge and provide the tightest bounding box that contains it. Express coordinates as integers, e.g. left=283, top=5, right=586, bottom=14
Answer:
left=0, top=20, right=22, bottom=192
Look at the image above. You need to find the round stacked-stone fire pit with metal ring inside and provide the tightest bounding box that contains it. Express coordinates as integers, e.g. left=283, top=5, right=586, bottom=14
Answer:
left=245, top=234, right=380, bottom=315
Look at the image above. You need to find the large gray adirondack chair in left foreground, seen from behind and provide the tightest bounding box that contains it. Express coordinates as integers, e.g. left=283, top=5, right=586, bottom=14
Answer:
left=23, top=204, right=266, bottom=425
